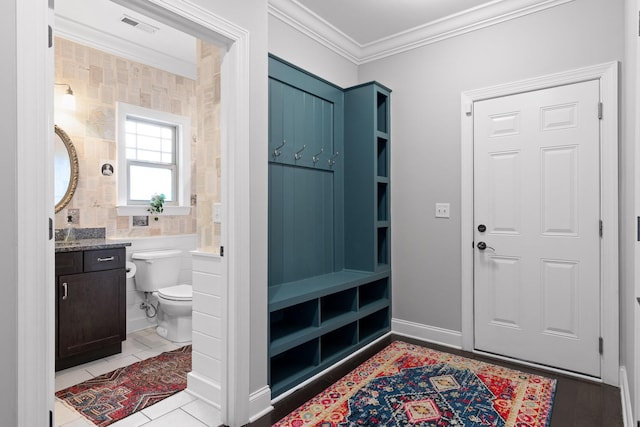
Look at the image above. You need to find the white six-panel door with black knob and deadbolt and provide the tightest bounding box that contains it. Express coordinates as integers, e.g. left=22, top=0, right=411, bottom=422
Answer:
left=474, top=80, right=600, bottom=377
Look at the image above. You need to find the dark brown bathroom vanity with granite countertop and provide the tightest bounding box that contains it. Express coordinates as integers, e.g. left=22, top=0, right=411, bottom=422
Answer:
left=55, top=234, right=130, bottom=371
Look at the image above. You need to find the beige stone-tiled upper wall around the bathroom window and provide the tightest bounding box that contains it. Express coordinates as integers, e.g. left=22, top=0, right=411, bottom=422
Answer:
left=55, top=38, right=225, bottom=250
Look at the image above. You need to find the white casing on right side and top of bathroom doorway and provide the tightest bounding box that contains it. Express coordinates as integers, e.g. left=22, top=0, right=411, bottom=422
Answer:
left=135, top=0, right=258, bottom=426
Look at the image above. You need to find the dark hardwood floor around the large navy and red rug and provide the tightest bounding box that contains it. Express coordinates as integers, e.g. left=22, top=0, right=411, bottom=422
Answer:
left=248, top=335, right=623, bottom=427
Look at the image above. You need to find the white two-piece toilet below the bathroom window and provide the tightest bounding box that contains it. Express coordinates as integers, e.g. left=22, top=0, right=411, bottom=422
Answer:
left=131, top=249, right=193, bottom=343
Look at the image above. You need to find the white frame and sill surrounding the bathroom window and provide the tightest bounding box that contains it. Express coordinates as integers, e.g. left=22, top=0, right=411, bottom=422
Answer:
left=116, top=102, right=191, bottom=216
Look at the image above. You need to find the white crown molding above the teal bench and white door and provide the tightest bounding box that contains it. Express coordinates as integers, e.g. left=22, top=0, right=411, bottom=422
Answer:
left=269, top=0, right=575, bottom=65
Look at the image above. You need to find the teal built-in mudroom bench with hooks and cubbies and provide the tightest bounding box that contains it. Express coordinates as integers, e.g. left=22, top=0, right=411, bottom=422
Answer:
left=269, top=57, right=391, bottom=396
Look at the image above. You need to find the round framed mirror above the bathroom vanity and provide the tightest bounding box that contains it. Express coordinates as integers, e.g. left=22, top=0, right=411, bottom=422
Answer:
left=53, top=125, right=78, bottom=213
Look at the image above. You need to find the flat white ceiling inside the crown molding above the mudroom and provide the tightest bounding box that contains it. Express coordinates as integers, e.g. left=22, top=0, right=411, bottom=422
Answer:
left=298, top=0, right=495, bottom=45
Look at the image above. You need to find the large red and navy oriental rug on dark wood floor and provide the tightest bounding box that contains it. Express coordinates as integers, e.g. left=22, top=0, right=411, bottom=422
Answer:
left=274, top=341, right=556, bottom=427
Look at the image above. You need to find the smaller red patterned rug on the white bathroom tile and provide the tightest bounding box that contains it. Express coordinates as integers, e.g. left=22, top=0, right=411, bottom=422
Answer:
left=56, top=345, right=191, bottom=427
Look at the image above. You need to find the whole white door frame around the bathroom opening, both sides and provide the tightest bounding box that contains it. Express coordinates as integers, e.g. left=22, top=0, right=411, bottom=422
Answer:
left=13, top=0, right=251, bottom=427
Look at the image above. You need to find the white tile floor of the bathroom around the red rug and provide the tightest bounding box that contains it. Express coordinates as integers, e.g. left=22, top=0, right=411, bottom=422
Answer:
left=55, top=328, right=220, bottom=427
